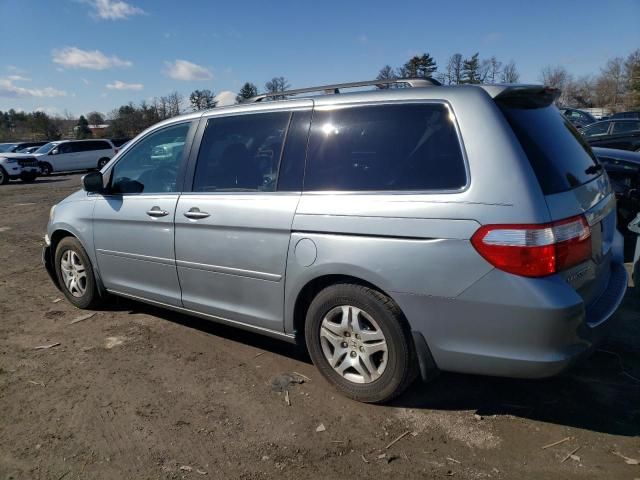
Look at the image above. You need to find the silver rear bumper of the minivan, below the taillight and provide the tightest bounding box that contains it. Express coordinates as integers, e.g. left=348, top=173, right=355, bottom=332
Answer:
left=392, top=262, right=628, bottom=378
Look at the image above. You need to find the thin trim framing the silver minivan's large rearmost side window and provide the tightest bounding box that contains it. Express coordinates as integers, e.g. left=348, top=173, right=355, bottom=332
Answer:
left=302, top=99, right=471, bottom=196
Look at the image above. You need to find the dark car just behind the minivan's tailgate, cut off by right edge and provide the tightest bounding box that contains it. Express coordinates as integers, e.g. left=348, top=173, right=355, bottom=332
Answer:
left=593, top=147, right=640, bottom=261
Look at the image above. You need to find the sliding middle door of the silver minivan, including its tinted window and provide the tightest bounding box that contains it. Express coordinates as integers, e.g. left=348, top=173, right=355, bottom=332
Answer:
left=175, top=107, right=310, bottom=331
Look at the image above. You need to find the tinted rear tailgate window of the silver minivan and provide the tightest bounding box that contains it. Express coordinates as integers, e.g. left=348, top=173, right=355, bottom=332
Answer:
left=498, top=102, right=601, bottom=195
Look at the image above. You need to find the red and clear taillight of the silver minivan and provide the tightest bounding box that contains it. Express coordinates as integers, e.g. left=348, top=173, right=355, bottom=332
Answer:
left=471, top=216, right=591, bottom=277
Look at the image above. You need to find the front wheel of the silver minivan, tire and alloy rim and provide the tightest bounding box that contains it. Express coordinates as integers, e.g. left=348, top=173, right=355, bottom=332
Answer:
left=55, top=237, right=98, bottom=309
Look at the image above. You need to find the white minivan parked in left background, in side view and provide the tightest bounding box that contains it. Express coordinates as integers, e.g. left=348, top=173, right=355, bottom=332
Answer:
left=34, top=140, right=115, bottom=175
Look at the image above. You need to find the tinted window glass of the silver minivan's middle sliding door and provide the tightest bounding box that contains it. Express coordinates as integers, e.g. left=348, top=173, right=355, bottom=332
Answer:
left=193, top=112, right=291, bottom=192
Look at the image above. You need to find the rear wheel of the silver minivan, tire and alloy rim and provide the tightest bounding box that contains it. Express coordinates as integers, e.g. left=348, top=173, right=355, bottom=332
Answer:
left=305, top=283, right=418, bottom=403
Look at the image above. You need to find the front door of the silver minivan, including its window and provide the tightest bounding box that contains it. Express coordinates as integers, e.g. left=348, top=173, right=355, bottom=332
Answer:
left=93, top=122, right=191, bottom=306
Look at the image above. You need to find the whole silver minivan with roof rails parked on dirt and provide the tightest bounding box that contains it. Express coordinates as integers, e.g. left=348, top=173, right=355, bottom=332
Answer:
left=43, top=79, right=627, bottom=402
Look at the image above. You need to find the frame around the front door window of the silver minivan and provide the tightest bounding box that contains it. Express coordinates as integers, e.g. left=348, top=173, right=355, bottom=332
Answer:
left=99, top=118, right=199, bottom=198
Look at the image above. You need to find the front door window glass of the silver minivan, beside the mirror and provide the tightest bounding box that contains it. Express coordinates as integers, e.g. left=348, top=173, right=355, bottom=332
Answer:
left=110, top=123, right=191, bottom=194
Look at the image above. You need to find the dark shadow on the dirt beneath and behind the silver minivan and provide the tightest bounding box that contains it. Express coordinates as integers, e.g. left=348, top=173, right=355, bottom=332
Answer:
left=100, top=289, right=640, bottom=436
